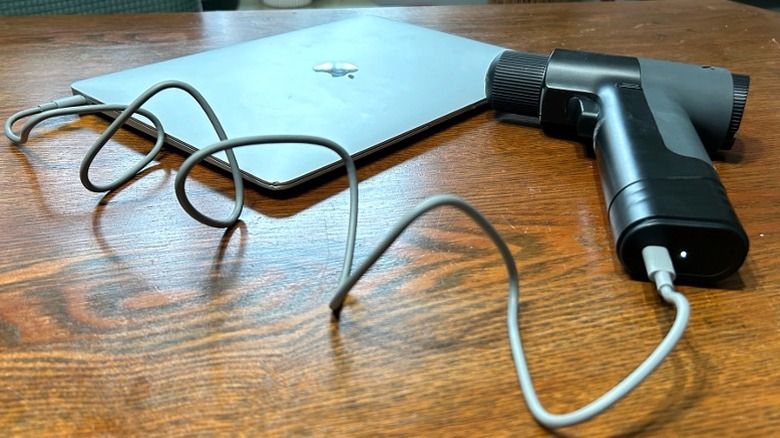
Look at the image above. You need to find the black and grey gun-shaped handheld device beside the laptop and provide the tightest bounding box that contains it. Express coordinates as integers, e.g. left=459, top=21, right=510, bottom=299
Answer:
left=486, top=49, right=750, bottom=283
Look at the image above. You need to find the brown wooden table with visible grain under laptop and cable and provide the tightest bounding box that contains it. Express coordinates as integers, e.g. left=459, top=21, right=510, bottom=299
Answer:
left=0, top=0, right=780, bottom=436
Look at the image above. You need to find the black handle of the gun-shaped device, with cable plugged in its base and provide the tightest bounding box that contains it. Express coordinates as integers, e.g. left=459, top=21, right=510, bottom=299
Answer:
left=596, top=83, right=748, bottom=282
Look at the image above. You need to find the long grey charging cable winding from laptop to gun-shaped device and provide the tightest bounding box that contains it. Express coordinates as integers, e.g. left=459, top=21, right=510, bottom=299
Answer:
left=5, top=81, right=690, bottom=428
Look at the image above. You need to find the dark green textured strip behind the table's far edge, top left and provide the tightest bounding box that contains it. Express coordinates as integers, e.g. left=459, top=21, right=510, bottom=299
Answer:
left=0, top=0, right=203, bottom=16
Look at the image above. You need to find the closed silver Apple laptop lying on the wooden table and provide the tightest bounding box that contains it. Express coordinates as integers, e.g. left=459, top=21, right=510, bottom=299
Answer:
left=72, top=16, right=504, bottom=190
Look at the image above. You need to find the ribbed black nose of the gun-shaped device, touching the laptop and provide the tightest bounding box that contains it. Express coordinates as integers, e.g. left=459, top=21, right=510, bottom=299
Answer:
left=485, top=50, right=550, bottom=119
